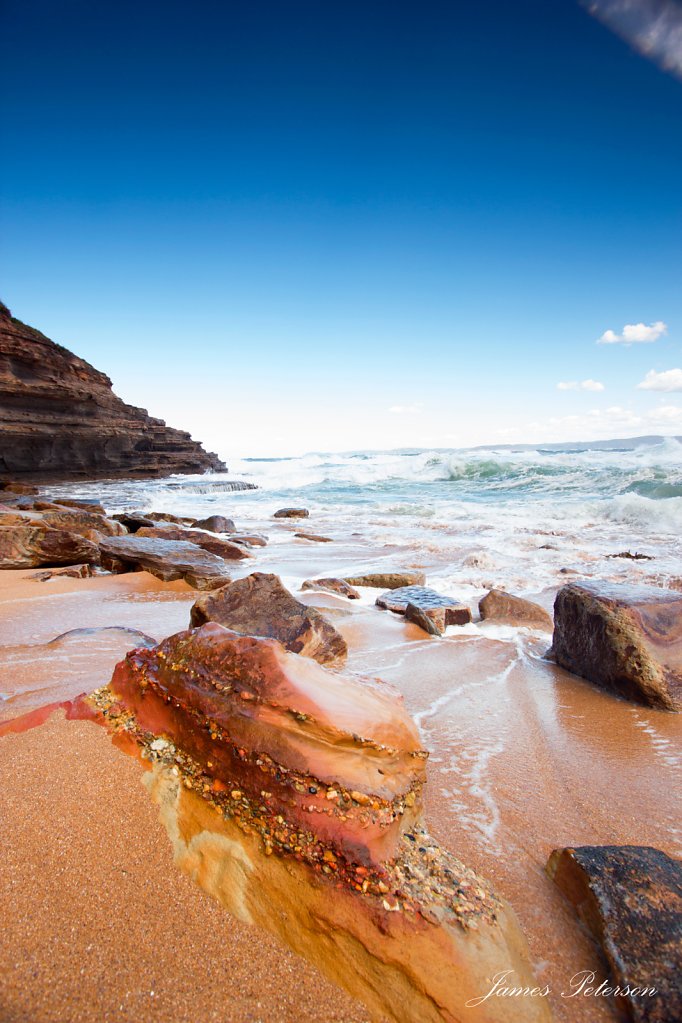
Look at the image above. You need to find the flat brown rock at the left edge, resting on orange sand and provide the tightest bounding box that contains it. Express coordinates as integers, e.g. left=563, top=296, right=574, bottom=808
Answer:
left=0, top=525, right=99, bottom=569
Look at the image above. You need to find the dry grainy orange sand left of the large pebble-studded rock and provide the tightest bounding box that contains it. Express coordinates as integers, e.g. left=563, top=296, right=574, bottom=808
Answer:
left=0, top=714, right=367, bottom=1023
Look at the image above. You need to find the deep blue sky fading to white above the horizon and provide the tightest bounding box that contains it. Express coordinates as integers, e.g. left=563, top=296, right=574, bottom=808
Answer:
left=0, top=0, right=682, bottom=456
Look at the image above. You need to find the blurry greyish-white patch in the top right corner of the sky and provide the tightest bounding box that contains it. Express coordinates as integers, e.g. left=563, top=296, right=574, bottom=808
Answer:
left=582, top=0, right=682, bottom=78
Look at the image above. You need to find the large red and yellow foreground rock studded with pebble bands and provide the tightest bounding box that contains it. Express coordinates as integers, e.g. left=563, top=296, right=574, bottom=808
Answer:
left=93, top=624, right=549, bottom=1023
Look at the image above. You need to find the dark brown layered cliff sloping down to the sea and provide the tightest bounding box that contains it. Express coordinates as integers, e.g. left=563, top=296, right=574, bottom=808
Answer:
left=0, top=303, right=225, bottom=481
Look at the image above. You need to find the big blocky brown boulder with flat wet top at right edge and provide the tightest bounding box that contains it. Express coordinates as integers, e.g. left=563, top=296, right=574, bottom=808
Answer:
left=551, top=582, right=682, bottom=710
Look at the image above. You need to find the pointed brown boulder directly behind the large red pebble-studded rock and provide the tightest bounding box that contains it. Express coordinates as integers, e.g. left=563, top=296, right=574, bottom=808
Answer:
left=190, top=572, right=348, bottom=665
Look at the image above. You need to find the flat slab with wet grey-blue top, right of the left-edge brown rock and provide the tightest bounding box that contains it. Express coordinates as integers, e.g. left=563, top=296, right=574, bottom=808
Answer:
left=99, top=536, right=229, bottom=589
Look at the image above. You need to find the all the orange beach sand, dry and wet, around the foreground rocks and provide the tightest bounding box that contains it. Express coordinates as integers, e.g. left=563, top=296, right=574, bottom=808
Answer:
left=0, top=560, right=682, bottom=1023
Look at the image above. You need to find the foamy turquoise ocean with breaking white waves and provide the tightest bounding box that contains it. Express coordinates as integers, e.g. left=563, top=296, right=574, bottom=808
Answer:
left=42, top=438, right=682, bottom=599
